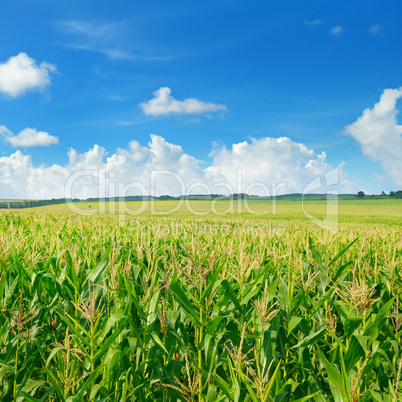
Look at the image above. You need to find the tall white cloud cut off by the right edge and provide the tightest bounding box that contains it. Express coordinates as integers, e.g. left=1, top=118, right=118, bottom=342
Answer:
left=345, top=87, right=402, bottom=186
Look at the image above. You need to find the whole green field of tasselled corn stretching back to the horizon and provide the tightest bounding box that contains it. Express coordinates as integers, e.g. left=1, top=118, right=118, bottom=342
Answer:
left=0, top=200, right=402, bottom=402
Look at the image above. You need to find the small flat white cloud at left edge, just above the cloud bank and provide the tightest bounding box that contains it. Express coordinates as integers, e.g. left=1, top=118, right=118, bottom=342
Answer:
left=0, top=126, right=59, bottom=148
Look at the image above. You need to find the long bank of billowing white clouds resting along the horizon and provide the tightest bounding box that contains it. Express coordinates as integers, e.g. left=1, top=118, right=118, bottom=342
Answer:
left=0, top=135, right=346, bottom=198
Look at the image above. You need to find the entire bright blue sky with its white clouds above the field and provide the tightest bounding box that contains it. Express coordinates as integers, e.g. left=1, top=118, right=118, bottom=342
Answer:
left=0, top=0, right=402, bottom=198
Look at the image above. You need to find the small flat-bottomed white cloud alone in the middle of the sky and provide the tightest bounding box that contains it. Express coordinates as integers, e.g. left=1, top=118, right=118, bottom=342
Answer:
left=140, top=87, right=227, bottom=116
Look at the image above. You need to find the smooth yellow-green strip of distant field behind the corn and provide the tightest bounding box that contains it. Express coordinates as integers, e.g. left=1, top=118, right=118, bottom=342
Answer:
left=25, top=199, right=402, bottom=223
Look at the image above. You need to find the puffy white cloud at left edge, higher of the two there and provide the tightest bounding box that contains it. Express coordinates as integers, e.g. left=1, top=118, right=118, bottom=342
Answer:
left=0, top=53, right=57, bottom=98
